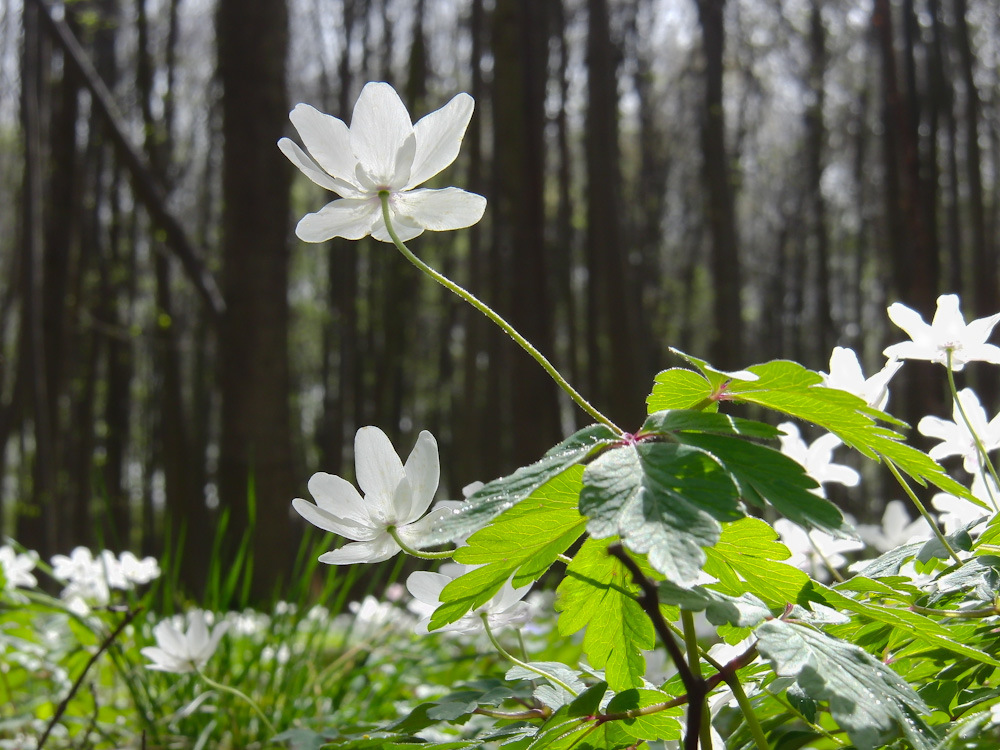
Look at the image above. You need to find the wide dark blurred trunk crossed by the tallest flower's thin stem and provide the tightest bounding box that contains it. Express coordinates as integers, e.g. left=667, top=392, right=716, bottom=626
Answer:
left=491, top=0, right=561, bottom=466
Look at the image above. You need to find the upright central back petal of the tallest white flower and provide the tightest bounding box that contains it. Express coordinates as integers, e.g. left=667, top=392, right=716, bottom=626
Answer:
left=351, top=82, right=413, bottom=189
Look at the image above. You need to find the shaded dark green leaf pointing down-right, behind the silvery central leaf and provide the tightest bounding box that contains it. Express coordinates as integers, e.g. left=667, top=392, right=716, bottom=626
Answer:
left=677, top=433, right=854, bottom=538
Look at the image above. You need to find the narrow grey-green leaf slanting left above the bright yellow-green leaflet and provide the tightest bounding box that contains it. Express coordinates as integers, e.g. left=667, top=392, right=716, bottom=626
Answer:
left=421, top=424, right=618, bottom=547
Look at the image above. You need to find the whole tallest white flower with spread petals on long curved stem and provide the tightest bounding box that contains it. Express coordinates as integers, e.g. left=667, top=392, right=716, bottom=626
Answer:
left=278, top=83, right=486, bottom=242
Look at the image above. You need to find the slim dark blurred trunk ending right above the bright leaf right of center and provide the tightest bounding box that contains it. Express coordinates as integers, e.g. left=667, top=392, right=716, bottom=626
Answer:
left=696, top=0, right=746, bottom=369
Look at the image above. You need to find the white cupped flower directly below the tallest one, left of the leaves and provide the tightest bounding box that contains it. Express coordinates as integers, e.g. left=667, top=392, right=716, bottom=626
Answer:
left=292, top=427, right=453, bottom=565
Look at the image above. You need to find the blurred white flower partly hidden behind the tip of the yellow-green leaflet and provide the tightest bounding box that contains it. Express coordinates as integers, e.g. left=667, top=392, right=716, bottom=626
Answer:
left=406, top=563, right=531, bottom=633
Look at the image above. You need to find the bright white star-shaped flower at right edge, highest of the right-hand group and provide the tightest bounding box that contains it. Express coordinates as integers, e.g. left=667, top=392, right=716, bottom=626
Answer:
left=883, top=294, right=1000, bottom=372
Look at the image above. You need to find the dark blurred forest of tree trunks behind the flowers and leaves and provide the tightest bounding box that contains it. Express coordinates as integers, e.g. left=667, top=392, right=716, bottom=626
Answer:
left=0, top=0, right=1000, bottom=595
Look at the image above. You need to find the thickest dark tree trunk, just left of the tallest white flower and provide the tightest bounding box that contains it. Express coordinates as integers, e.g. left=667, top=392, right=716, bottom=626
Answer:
left=215, top=0, right=297, bottom=600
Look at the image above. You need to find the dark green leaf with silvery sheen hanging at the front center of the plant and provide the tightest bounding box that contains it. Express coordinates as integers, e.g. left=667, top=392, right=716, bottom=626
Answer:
left=580, top=441, right=743, bottom=586
